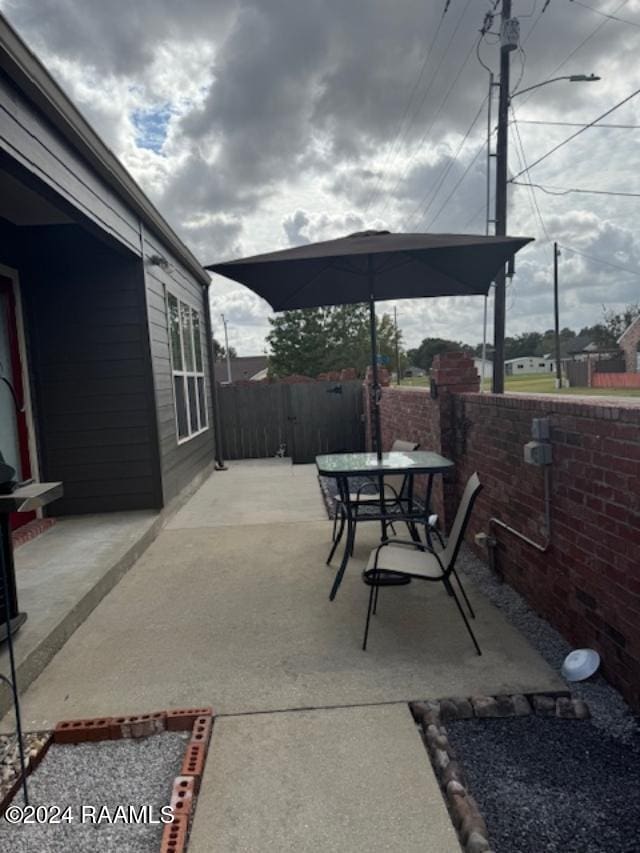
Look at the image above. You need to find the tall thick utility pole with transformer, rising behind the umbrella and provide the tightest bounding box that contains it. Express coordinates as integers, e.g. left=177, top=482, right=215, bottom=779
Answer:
left=491, top=0, right=516, bottom=394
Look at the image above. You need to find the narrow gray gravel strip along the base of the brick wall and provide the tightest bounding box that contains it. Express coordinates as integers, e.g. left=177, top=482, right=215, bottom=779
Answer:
left=458, top=546, right=640, bottom=744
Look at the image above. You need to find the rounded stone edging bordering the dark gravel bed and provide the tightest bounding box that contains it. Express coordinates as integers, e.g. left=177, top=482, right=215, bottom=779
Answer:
left=409, top=691, right=591, bottom=853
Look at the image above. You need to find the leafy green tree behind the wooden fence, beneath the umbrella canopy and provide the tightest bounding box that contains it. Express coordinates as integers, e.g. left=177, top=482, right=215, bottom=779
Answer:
left=267, top=305, right=401, bottom=377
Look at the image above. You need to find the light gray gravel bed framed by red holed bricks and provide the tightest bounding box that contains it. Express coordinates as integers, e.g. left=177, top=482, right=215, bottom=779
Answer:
left=0, top=732, right=191, bottom=853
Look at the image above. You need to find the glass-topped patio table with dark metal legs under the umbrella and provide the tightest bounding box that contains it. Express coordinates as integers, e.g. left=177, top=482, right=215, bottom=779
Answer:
left=316, top=450, right=454, bottom=601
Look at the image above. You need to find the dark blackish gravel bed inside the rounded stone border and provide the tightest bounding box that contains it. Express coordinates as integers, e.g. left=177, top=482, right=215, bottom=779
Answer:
left=446, top=715, right=640, bottom=853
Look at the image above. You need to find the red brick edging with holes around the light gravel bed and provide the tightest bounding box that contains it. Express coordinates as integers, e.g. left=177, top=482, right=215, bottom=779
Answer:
left=0, top=707, right=216, bottom=853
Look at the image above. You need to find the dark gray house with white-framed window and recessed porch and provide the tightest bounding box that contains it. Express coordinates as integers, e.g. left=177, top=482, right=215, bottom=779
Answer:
left=0, top=15, right=214, bottom=528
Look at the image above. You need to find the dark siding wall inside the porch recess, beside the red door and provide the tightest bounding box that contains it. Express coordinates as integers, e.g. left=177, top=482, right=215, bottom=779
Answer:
left=20, top=225, right=162, bottom=515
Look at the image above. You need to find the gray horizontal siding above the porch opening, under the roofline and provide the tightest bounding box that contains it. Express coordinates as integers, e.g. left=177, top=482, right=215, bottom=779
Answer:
left=0, top=72, right=140, bottom=254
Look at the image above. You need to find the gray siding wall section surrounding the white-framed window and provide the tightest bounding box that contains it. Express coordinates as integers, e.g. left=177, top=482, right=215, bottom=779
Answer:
left=143, top=228, right=214, bottom=503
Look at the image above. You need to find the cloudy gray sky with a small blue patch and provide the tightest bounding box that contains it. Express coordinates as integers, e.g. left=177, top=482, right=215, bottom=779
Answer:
left=0, top=0, right=640, bottom=355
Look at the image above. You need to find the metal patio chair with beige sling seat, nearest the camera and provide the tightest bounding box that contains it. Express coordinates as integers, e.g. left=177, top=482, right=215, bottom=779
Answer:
left=362, top=473, right=482, bottom=655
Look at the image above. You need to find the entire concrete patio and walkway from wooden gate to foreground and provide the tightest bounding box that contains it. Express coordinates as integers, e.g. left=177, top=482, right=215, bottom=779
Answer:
left=3, top=460, right=564, bottom=853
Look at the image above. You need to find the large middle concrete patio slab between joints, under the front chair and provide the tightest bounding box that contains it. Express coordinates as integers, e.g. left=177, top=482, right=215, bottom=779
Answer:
left=7, top=510, right=563, bottom=728
